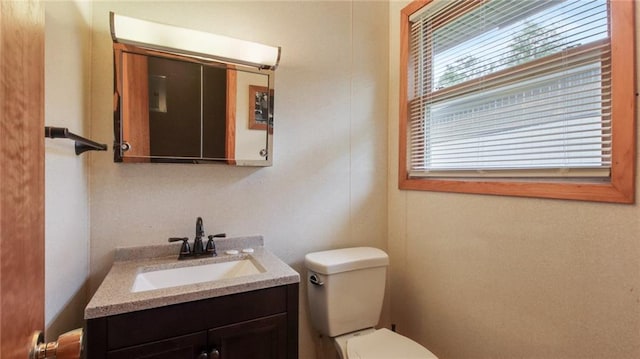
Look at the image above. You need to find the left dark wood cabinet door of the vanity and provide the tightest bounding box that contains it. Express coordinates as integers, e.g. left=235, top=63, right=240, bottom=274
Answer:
left=107, top=331, right=207, bottom=359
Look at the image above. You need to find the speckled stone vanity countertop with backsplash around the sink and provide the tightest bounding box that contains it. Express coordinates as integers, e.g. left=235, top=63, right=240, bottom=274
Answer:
left=84, top=236, right=300, bottom=319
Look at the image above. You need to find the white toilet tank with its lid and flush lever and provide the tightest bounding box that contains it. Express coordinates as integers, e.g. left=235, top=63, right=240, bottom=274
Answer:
left=304, top=247, right=389, bottom=337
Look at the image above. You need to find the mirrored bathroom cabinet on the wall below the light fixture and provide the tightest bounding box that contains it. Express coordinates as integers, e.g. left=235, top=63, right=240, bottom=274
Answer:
left=113, top=43, right=274, bottom=166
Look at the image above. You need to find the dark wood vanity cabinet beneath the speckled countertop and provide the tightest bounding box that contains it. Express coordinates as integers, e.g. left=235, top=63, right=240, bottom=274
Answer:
left=85, top=283, right=298, bottom=359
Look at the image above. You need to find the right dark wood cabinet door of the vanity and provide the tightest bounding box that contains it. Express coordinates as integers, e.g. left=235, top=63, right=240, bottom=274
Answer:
left=209, top=314, right=287, bottom=359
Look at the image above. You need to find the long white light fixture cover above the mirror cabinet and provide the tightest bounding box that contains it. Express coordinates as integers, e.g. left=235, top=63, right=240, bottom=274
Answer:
left=110, top=12, right=280, bottom=70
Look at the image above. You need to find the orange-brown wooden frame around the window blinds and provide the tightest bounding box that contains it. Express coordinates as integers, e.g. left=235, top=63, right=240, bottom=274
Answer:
left=398, top=0, right=637, bottom=203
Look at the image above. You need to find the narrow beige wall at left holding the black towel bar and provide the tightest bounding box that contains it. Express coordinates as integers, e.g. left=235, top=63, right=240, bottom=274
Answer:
left=45, top=2, right=91, bottom=339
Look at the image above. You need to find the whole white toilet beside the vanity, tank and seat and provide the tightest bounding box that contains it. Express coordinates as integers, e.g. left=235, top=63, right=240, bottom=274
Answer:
left=304, top=247, right=437, bottom=359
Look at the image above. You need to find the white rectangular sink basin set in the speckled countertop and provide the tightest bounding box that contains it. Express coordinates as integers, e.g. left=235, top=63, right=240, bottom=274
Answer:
left=131, top=259, right=265, bottom=293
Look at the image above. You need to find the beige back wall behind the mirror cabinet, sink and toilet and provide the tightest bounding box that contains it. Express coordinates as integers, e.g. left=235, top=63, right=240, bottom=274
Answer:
left=90, top=1, right=388, bottom=358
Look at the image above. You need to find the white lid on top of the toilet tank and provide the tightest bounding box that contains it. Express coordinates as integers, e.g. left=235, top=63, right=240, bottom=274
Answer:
left=304, top=247, right=389, bottom=274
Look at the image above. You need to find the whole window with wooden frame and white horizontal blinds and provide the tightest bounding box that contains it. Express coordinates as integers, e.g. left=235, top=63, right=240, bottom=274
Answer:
left=399, top=0, right=636, bottom=203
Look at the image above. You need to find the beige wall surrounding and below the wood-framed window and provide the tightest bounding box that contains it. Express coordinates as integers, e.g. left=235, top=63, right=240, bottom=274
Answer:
left=388, top=1, right=640, bottom=359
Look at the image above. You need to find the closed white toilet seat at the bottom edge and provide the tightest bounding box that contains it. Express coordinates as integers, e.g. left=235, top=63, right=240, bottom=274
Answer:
left=346, top=328, right=438, bottom=359
